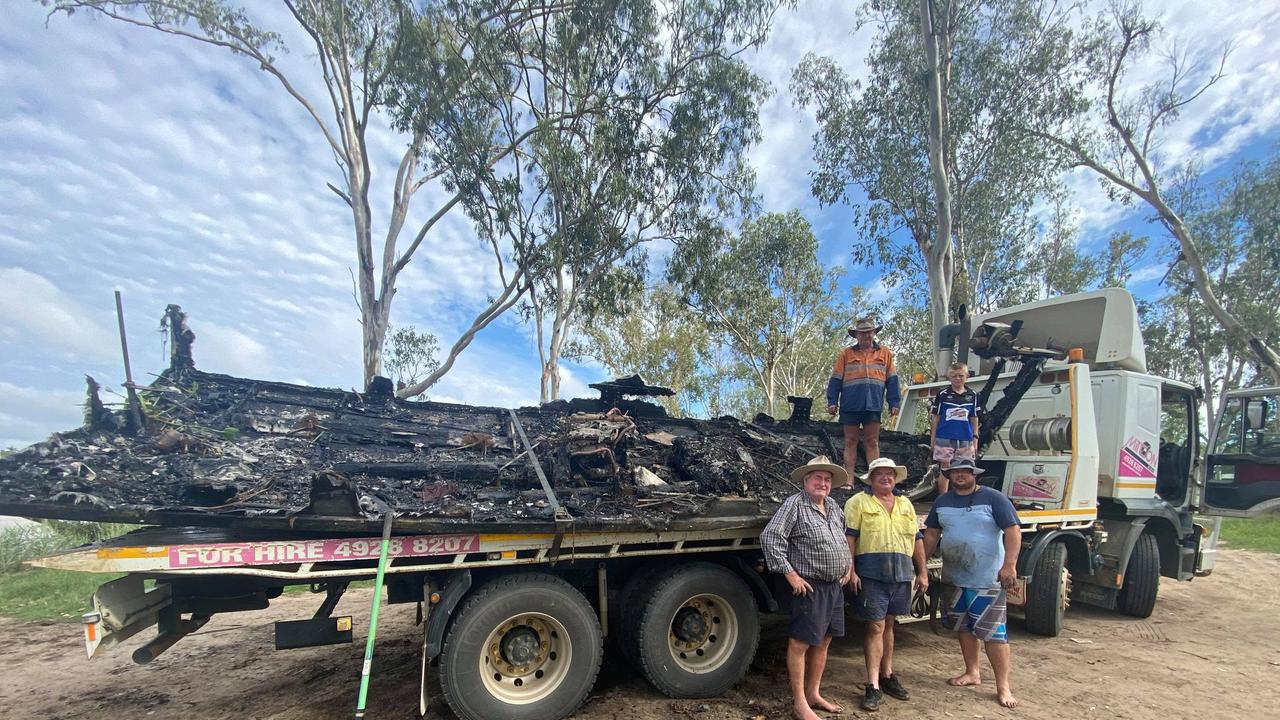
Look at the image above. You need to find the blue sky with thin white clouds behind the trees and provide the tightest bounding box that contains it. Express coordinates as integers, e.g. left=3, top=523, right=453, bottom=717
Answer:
left=0, top=1, right=1280, bottom=447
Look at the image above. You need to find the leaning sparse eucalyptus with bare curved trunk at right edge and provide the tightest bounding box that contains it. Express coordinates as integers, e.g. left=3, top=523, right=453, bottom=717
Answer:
left=1025, top=3, right=1280, bottom=383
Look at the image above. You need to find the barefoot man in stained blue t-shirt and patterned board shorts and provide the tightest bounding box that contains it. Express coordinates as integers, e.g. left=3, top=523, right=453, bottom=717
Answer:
left=924, top=459, right=1023, bottom=707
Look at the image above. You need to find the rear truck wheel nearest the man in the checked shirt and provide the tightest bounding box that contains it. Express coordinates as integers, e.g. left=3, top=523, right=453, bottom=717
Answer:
left=623, top=562, right=760, bottom=698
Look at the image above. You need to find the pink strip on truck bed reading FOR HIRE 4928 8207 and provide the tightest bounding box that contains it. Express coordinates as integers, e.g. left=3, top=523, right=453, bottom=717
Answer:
left=169, top=536, right=480, bottom=569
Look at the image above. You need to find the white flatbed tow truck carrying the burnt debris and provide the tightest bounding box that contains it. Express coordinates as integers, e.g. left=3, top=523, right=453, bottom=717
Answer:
left=0, top=290, right=1280, bottom=720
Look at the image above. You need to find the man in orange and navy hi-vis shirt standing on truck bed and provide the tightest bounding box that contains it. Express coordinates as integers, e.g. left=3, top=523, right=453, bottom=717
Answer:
left=827, top=318, right=901, bottom=487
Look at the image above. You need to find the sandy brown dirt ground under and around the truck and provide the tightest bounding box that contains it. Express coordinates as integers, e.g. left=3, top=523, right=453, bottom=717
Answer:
left=0, top=551, right=1280, bottom=720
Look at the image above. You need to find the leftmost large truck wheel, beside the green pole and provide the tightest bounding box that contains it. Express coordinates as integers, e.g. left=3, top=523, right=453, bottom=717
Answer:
left=440, top=573, right=604, bottom=720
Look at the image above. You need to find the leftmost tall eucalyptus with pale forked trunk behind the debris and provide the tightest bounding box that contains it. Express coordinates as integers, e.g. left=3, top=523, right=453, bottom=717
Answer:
left=41, top=0, right=529, bottom=383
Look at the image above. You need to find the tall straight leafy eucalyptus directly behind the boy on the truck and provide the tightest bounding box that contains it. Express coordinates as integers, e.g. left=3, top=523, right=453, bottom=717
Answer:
left=792, top=0, right=1082, bottom=376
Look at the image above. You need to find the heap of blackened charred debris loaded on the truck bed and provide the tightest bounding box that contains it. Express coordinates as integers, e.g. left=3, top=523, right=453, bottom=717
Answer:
left=0, top=305, right=927, bottom=529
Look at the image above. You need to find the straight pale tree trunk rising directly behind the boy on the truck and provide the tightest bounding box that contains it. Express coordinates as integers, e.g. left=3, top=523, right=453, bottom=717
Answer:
left=920, top=0, right=955, bottom=377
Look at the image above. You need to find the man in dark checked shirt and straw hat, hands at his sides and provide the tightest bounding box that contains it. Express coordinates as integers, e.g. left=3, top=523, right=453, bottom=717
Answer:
left=760, top=456, right=852, bottom=720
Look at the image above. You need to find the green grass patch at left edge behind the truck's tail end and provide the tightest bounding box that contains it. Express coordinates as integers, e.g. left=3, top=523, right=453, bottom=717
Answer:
left=0, top=520, right=134, bottom=621
